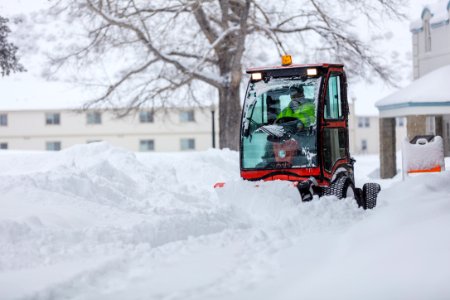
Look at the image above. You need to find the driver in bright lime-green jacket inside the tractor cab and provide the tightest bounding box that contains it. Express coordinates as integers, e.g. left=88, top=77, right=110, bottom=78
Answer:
left=275, top=86, right=316, bottom=130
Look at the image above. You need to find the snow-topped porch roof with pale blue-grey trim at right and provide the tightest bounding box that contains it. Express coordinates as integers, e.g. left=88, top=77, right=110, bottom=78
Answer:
left=376, top=65, right=450, bottom=117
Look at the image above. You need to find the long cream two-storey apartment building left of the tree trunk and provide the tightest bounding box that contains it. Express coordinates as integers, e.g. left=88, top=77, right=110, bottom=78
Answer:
left=0, top=108, right=218, bottom=152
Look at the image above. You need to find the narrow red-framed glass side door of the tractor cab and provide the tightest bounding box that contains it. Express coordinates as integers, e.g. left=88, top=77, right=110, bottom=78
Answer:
left=321, top=68, right=353, bottom=180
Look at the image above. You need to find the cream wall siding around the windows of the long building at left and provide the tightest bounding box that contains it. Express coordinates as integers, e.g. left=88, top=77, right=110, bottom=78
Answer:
left=0, top=109, right=218, bottom=152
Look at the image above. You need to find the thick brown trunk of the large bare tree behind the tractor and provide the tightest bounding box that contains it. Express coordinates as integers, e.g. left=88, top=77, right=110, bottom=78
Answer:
left=219, top=84, right=241, bottom=150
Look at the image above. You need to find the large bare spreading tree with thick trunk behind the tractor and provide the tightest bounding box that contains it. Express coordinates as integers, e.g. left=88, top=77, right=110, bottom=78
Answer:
left=48, top=0, right=402, bottom=149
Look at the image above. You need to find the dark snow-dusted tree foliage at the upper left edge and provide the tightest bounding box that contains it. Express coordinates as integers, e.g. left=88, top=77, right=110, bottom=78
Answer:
left=0, top=16, right=25, bottom=76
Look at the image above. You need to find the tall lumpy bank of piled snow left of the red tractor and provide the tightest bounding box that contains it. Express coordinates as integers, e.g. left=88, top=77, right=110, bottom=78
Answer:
left=0, top=143, right=243, bottom=297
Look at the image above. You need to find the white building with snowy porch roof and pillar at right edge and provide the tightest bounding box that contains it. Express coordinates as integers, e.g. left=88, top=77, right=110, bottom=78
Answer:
left=377, top=0, right=450, bottom=178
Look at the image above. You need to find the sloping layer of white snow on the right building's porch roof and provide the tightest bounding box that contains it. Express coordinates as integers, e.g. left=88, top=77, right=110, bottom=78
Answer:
left=376, top=65, right=450, bottom=109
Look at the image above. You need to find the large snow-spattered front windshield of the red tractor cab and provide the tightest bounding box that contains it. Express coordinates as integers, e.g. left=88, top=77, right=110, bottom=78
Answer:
left=241, top=78, right=321, bottom=169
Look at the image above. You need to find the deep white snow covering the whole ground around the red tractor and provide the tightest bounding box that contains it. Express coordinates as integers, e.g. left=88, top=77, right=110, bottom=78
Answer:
left=0, top=143, right=450, bottom=300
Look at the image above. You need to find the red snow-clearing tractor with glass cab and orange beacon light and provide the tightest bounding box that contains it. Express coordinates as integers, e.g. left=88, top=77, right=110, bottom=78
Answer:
left=215, top=56, right=380, bottom=209
